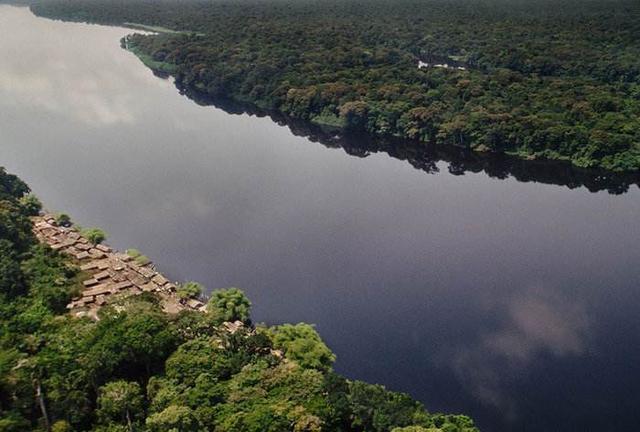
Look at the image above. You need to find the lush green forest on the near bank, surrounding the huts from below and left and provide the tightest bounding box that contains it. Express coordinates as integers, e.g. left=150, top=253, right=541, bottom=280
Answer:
left=0, top=168, right=477, bottom=432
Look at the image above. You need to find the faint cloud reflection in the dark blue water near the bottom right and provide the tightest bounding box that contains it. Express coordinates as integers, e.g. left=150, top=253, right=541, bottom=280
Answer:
left=452, top=288, right=589, bottom=419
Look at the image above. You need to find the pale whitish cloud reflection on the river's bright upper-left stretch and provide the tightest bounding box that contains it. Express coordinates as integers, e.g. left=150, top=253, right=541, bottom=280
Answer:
left=0, top=6, right=162, bottom=127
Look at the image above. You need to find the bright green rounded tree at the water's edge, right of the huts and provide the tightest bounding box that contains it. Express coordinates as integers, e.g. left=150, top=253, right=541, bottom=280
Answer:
left=269, top=323, right=336, bottom=370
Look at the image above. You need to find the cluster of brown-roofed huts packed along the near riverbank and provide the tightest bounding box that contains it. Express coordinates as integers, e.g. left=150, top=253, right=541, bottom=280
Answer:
left=33, top=215, right=205, bottom=317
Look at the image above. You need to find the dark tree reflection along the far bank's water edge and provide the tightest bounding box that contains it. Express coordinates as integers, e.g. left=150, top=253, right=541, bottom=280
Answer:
left=170, top=80, right=640, bottom=195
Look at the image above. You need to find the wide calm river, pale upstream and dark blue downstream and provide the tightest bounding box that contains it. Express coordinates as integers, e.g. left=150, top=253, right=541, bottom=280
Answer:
left=0, top=6, right=640, bottom=432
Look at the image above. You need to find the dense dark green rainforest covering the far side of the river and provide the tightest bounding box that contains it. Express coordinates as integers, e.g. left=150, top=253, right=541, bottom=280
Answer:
left=26, top=0, right=640, bottom=171
